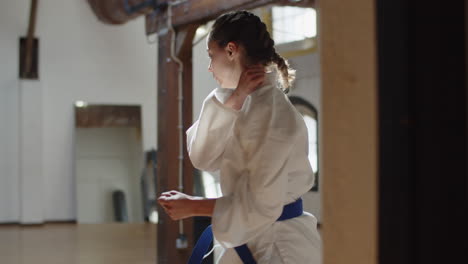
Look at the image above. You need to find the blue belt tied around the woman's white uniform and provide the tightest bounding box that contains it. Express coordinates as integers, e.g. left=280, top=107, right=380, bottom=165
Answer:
left=188, top=198, right=304, bottom=264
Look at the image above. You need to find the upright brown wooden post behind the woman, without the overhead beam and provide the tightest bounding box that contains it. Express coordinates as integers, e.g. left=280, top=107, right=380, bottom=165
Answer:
left=157, top=25, right=197, bottom=264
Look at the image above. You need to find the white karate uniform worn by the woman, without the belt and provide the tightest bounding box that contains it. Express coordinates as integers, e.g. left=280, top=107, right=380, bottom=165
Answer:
left=187, top=73, right=321, bottom=264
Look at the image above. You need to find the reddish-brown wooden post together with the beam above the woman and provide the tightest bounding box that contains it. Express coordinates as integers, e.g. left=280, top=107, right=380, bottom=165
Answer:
left=153, top=0, right=300, bottom=264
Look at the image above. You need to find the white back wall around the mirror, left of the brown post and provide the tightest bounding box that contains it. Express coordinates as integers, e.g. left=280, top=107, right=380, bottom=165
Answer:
left=0, top=0, right=157, bottom=222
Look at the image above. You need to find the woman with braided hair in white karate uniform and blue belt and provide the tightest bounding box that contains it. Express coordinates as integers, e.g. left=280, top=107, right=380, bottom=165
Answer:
left=158, top=11, right=321, bottom=264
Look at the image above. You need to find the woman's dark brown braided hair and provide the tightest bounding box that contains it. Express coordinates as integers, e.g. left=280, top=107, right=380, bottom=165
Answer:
left=209, top=11, right=296, bottom=93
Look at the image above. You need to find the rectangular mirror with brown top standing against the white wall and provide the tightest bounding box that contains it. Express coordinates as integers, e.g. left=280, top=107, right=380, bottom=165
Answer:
left=75, top=101, right=155, bottom=223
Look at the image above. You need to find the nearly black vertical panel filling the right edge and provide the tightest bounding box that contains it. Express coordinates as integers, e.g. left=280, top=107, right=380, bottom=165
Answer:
left=376, top=0, right=468, bottom=264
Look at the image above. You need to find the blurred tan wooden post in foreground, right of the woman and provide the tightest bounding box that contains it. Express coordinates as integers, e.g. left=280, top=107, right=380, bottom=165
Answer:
left=319, top=0, right=378, bottom=264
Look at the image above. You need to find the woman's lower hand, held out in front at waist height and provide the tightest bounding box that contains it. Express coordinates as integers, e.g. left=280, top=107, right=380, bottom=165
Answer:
left=158, top=191, right=200, bottom=220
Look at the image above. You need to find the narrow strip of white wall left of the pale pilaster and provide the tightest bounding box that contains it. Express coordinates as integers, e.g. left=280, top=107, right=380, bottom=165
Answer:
left=0, top=1, right=28, bottom=222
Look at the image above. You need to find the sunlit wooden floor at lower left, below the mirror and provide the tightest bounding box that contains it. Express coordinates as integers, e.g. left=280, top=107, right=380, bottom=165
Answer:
left=0, top=223, right=157, bottom=264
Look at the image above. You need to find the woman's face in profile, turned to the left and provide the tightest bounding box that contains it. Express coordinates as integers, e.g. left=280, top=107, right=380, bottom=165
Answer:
left=207, top=41, right=239, bottom=88
